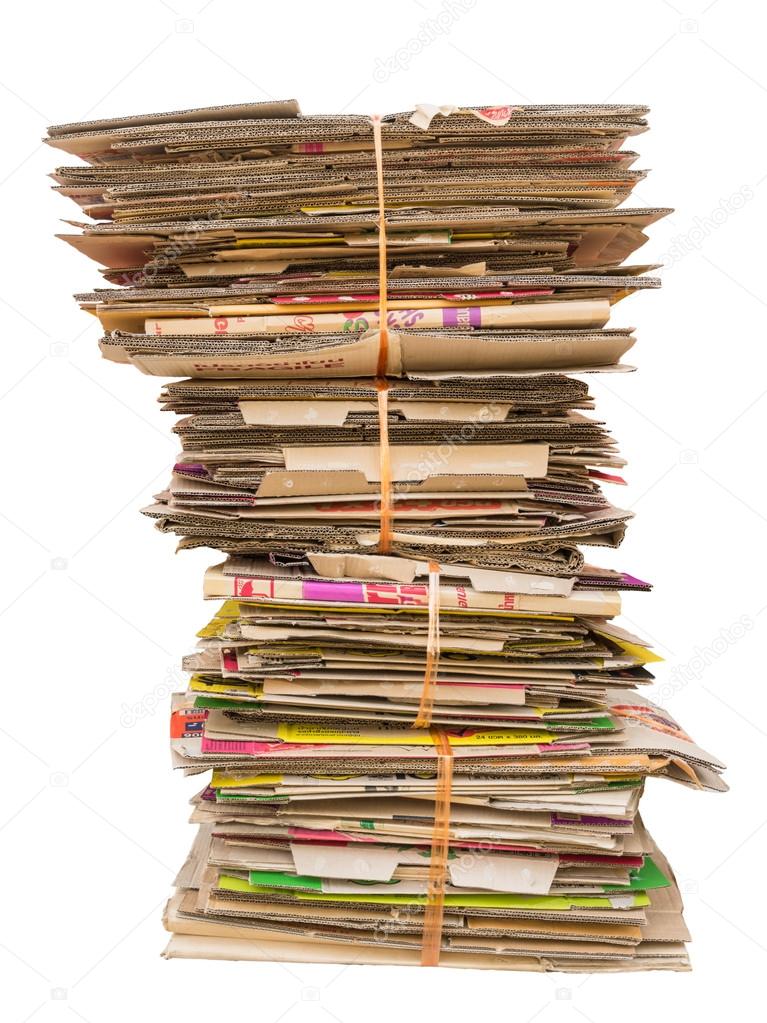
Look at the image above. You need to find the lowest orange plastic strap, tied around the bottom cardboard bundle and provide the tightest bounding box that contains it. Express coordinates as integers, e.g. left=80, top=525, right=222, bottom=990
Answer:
left=420, top=728, right=453, bottom=966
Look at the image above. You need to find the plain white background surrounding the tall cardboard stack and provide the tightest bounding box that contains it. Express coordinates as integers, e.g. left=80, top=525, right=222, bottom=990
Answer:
left=0, top=0, right=767, bottom=1023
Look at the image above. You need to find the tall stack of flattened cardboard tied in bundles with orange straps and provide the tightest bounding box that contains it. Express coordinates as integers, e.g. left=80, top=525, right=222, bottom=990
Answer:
left=48, top=101, right=725, bottom=971
